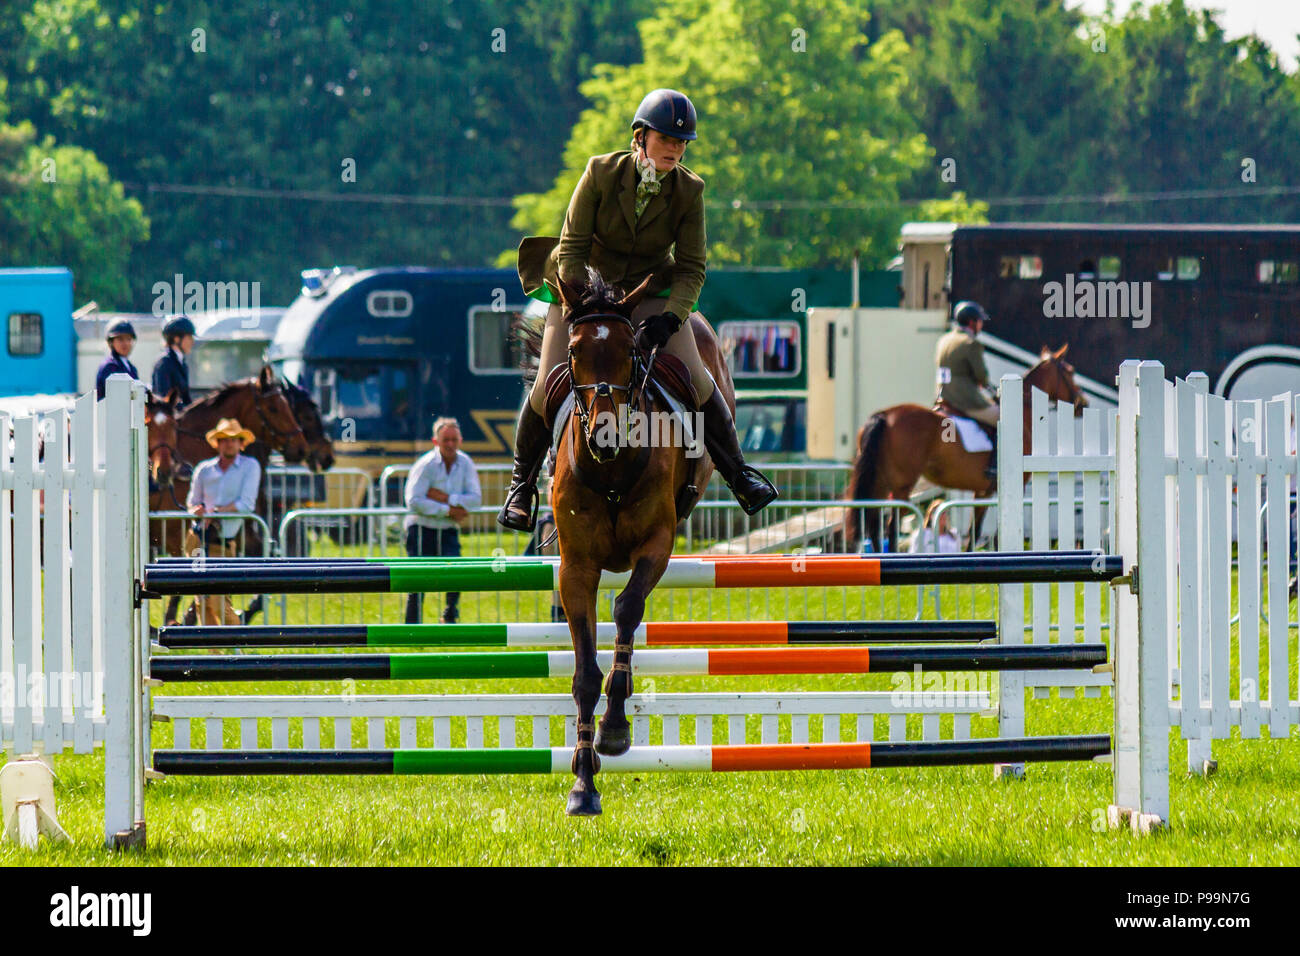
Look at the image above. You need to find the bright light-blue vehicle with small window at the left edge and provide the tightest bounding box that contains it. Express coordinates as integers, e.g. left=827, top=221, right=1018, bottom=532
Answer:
left=0, top=268, right=77, bottom=397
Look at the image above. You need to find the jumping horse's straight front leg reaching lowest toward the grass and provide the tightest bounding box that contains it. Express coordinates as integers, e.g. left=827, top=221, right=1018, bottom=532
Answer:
left=560, top=561, right=601, bottom=817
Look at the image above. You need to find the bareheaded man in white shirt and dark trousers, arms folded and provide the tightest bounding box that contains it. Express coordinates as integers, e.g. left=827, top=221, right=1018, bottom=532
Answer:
left=404, top=418, right=484, bottom=624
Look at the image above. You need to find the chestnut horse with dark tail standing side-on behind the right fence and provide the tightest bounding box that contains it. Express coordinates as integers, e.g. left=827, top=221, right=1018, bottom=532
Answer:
left=844, top=345, right=1088, bottom=553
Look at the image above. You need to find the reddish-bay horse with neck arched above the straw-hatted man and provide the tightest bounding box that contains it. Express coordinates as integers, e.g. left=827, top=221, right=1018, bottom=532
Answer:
left=150, top=365, right=307, bottom=624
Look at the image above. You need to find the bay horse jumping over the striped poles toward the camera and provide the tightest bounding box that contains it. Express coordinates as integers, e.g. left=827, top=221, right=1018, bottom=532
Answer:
left=538, top=269, right=736, bottom=816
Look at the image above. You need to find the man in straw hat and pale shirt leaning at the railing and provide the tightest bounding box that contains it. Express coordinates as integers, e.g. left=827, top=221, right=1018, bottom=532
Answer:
left=185, top=419, right=261, bottom=624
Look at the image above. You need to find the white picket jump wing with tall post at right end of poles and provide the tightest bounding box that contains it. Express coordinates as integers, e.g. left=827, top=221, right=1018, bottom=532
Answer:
left=1113, top=362, right=1300, bottom=827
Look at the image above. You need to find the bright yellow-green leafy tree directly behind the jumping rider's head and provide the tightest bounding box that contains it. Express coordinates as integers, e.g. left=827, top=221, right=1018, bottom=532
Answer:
left=501, top=0, right=931, bottom=267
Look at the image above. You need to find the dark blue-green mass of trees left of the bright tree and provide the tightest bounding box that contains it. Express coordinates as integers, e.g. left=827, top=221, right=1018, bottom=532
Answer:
left=0, top=0, right=649, bottom=307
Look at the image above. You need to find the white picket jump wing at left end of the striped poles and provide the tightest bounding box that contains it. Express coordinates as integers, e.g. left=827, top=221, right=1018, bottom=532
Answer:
left=0, top=377, right=147, bottom=753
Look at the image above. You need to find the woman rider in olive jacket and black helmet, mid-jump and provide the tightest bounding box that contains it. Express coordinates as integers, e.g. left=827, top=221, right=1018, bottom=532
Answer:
left=497, top=90, right=776, bottom=531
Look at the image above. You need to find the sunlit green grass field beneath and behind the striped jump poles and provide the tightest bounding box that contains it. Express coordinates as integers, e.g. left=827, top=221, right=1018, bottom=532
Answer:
left=10, top=538, right=1300, bottom=866
